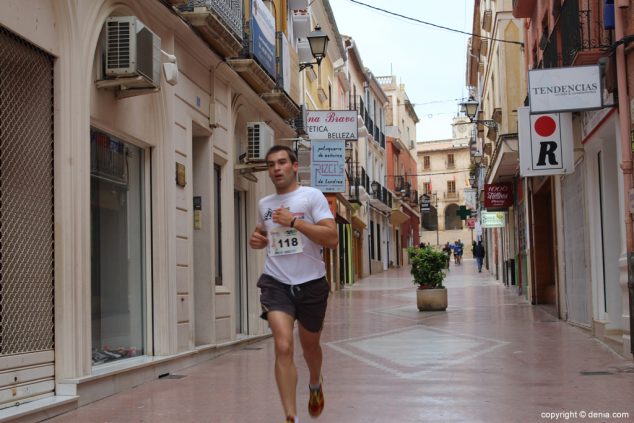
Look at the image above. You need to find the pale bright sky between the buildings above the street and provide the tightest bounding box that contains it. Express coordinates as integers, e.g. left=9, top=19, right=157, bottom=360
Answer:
left=330, top=0, right=473, bottom=141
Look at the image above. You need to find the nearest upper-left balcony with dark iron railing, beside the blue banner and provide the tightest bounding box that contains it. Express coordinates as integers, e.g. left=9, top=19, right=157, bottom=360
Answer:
left=179, top=0, right=243, bottom=58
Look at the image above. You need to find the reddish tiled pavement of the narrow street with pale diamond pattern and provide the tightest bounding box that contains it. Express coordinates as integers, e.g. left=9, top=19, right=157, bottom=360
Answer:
left=48, top=260, right=634, bottom=423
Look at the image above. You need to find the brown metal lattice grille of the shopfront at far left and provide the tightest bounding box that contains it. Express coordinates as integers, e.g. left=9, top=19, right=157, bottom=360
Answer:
left=0, top=27, right=54, bottom=356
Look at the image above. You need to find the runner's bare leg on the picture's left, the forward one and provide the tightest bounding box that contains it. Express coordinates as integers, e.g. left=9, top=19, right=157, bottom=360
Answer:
left=267, top=311, right=297, bottom=416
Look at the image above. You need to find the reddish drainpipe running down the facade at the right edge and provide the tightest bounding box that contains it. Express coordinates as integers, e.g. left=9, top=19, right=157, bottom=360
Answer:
left=614, top=0, right=634, bottom=354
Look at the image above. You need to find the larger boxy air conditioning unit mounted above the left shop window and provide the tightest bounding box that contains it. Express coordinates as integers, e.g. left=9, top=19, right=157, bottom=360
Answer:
left=104, top=16, right=161, bottom=88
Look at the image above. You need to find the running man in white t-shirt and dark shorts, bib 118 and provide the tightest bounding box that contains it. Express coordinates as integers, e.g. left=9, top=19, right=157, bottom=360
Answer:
left=249, top=145, right=339, bottom=423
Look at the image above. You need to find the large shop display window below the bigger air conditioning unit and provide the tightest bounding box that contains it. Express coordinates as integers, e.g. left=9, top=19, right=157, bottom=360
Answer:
left=90, top=129, right=146, bottom=365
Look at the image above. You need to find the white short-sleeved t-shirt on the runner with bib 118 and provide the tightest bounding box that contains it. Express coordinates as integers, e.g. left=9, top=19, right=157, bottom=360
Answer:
left=258, top=186, right=333, bottom=285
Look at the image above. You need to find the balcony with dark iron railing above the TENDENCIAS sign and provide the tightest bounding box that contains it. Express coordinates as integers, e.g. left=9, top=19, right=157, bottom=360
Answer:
left=556, top=0, right=612, bottom=67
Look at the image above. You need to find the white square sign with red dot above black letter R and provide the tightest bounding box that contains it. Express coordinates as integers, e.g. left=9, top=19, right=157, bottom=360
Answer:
left=518, top=107, right=575, bottom=176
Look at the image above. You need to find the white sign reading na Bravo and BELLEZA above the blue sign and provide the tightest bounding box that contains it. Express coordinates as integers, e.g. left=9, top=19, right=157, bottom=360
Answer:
left=306, top=110, right=359, bottom=140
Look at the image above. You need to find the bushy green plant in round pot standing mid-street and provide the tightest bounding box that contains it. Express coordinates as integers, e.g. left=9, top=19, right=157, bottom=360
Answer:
left=408, top=247, right=447, bottom=311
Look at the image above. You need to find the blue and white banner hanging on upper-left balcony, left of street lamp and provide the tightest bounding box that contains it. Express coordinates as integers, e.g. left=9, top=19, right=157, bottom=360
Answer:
left=250, top=0, right=276, bottom=79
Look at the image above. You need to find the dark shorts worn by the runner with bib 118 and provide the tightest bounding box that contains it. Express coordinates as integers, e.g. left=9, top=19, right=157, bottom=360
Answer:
left=258, top=274, right=330, bottom=332
